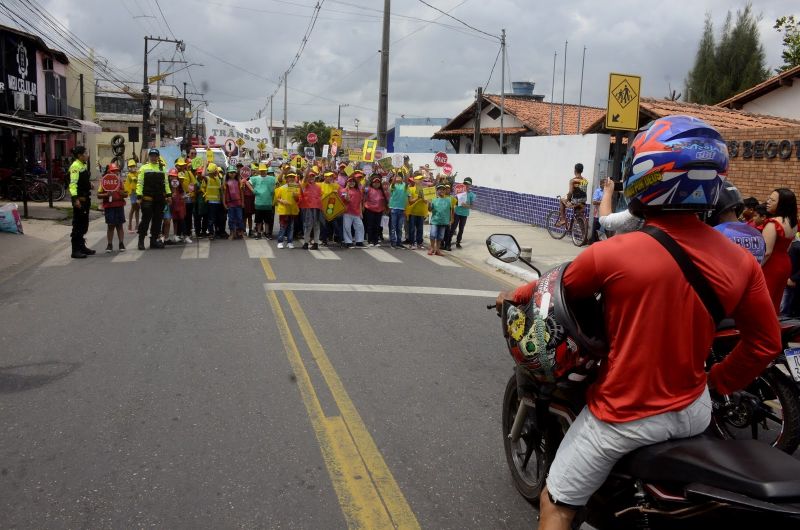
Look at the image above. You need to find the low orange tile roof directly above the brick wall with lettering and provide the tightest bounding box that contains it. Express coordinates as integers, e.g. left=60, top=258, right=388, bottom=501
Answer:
left=588, top=98, right=800, bottom=132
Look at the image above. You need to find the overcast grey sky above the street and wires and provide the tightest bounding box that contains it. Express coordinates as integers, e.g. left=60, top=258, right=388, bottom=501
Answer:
left=0, top=0, right=800, bottom=130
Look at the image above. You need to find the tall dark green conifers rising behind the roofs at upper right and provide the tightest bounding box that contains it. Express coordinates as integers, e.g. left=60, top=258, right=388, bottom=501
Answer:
left=686, top=4, right=769, bottom=105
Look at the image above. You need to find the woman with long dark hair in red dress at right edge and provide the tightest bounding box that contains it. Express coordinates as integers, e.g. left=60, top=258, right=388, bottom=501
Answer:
left=761, top=188, right=797, bottom=314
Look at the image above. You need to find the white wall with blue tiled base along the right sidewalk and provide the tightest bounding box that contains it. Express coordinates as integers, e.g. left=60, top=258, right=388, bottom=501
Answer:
left=396, top=134, right=610, bottom=225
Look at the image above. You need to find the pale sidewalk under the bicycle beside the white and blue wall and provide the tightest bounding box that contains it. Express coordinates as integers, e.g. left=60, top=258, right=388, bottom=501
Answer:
left=434, top=210, right=586, bottom=283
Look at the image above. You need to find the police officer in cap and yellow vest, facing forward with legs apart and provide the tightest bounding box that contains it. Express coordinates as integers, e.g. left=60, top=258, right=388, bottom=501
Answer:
left=136, top=149, right=172, bottom=250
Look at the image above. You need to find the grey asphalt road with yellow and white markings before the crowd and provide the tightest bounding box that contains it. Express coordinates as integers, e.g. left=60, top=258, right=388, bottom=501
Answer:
left=0, top=224, right=536, bottom=529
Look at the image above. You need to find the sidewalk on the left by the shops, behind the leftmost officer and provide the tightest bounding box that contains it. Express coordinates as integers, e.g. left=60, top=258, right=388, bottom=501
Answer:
left=0, top=201, right=102, bottom=282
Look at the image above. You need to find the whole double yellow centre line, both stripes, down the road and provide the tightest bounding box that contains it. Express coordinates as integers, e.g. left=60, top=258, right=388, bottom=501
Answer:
left=261, top=266, right=420, bottom=529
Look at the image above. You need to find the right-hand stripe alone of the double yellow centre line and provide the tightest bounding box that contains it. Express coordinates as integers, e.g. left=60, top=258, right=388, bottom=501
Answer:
left=283, top=291, right=419, bottom=528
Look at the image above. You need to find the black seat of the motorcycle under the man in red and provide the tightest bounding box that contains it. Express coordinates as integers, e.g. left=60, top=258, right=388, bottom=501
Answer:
left=614, top=435, right=800, bottom=500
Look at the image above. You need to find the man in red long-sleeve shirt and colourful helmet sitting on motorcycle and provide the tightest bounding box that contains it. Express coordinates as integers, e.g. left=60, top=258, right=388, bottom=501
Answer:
left=498, top=116, right=781, bottom=530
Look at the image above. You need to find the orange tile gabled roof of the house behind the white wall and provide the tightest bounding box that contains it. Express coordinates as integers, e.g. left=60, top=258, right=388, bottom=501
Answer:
left=433, top=94, right=605, bottom=138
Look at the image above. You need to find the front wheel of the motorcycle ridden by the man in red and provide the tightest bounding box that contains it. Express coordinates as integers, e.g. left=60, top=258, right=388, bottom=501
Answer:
left=502, top=375, right=557, bottom=507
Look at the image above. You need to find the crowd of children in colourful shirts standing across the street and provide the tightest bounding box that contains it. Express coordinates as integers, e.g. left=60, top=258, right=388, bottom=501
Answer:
left=98, top=153, right=476, bottom=255
